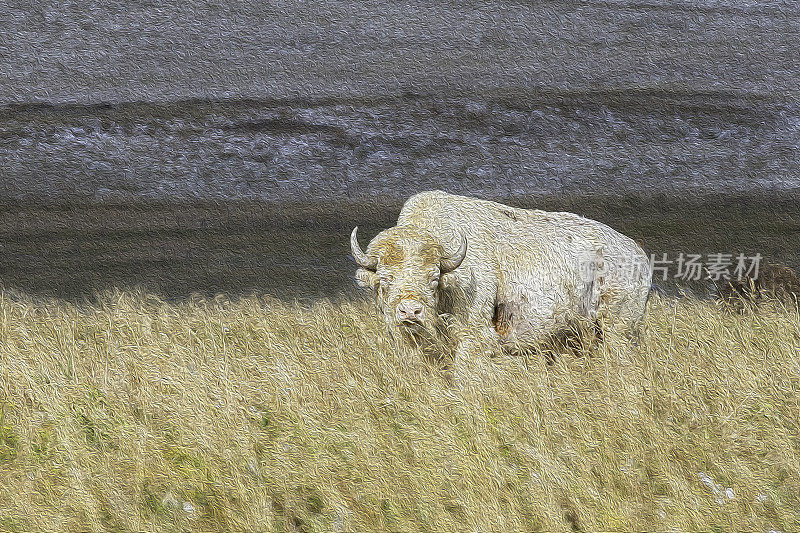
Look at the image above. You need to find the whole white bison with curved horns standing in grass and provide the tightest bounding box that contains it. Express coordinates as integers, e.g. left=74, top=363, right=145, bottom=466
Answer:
left=350, top=191, right=652, bottom=366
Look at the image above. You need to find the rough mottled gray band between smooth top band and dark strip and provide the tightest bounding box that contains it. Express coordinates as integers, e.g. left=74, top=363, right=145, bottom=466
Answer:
left=0, top=92, right=800, bottom=203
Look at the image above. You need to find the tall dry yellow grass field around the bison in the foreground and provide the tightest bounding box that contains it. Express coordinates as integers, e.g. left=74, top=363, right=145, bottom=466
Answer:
left=0, top=291, right=800, bottom=533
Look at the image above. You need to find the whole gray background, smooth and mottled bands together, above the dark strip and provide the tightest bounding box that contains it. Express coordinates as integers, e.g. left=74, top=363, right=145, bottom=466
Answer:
left=0, top=0, right=800, bottom=203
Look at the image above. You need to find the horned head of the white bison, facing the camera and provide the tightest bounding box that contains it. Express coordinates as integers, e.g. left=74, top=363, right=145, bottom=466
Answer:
left=350, top=226, right=467, bottom=333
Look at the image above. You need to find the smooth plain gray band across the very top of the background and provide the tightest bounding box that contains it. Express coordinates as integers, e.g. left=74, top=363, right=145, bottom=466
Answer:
left=0, top=0, right=800, bottom=103
